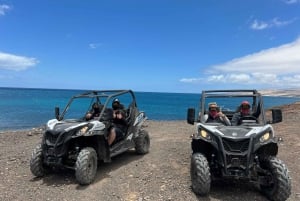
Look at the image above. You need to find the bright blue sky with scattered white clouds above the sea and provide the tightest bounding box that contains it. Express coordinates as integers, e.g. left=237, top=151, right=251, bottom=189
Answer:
left=0, top=0, right=300, bottom=93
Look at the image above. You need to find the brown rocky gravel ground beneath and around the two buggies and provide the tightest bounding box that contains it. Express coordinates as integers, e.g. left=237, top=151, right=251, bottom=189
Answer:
left=0, top=104, right=300, bottom=201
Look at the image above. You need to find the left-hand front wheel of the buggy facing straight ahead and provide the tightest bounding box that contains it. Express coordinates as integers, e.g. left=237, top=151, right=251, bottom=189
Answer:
left=191, top=153, right=211, bottom=195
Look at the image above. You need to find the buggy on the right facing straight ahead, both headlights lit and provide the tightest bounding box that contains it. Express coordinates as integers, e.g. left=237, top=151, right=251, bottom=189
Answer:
left=187, top=90, right=291, bottom=200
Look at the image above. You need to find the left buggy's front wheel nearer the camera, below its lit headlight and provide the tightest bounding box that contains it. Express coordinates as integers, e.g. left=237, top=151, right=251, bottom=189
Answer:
left=75, top=147, right=98, bottom=185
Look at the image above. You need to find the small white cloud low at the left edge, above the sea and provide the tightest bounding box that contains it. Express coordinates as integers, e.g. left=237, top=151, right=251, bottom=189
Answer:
left=0, top=52, right=39, bottom=71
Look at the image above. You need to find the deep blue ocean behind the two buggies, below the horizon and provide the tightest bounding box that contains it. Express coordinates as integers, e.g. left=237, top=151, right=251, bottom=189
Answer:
left=0, top=87, right=300, bottom=131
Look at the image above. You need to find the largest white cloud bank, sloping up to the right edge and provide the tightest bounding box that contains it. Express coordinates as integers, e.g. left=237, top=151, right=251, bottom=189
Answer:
left=180, top=38, right=300, bottom=87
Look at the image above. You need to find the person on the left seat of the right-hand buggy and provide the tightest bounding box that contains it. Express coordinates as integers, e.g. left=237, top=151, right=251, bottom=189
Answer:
left=205, top=102, right=231, bottom=126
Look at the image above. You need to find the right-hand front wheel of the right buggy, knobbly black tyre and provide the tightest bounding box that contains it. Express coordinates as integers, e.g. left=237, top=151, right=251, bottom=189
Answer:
left=260, top=156, right=291, bottom=201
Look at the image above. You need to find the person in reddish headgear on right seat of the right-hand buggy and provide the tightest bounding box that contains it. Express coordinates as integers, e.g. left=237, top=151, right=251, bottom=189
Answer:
left=231, top=101, right=259, bottom=126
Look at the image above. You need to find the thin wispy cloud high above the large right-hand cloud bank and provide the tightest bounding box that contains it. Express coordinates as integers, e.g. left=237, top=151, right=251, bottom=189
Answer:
left=250, top=18, right=297, bottom=30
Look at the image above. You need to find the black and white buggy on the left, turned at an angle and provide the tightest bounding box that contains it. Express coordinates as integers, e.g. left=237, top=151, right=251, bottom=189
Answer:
left=30, top=90, right=150, bottom=185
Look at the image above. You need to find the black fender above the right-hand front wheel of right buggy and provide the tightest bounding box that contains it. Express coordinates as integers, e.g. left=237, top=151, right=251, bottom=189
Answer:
left=253, top=139, right=278, bottom=156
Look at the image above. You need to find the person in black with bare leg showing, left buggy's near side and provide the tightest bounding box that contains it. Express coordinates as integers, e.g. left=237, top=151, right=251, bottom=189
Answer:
left=107, top=98, right=128, bottom=145
